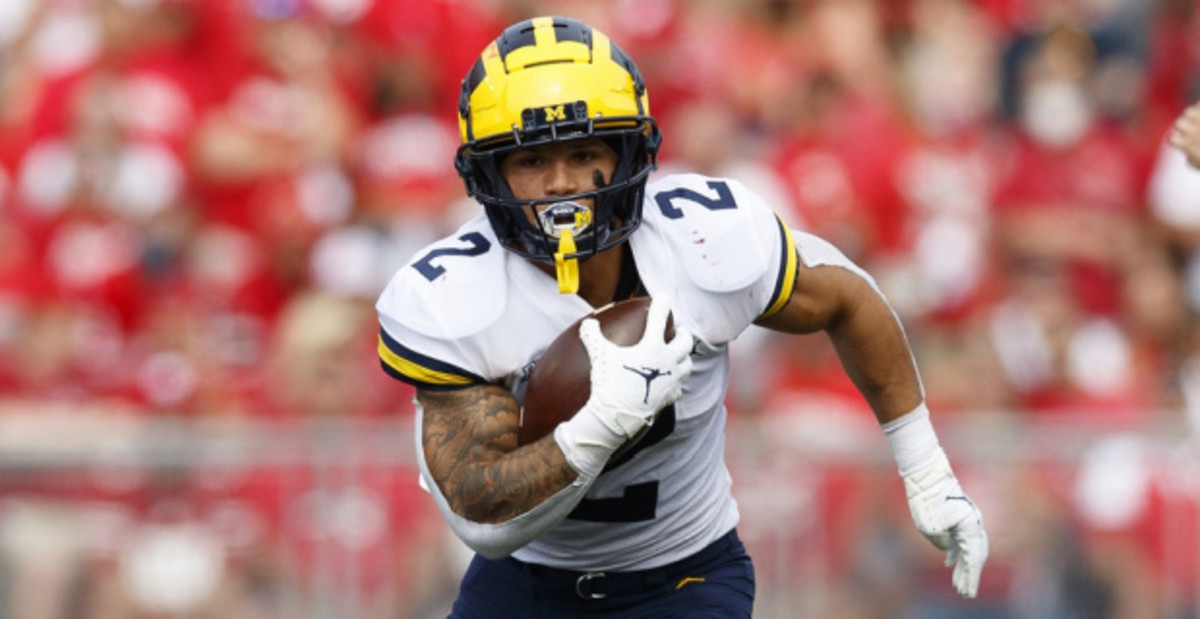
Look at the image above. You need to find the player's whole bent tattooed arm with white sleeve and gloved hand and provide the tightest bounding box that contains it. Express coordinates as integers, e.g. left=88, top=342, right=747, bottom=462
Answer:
left=416, top=297, right=692, bottom=559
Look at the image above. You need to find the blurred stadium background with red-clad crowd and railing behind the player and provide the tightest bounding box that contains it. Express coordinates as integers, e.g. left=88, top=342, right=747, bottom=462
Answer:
left=0, top=0, right=1200, bottom=619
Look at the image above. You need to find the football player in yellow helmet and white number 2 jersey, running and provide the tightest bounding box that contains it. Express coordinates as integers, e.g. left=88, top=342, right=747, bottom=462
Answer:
left=377, top=17, right=988, bottom=619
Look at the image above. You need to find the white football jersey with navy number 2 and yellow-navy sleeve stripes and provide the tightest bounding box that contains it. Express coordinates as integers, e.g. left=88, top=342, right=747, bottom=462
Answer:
left=377, top=174, right=797, bottom=570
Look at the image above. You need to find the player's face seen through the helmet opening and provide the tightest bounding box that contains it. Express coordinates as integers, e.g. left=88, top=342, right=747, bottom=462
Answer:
left=500, top=138, right=618, bottom=208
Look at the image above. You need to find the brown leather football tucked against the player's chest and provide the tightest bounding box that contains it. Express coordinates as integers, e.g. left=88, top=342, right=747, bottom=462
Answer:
left=518, top=298, right=674, bottom=445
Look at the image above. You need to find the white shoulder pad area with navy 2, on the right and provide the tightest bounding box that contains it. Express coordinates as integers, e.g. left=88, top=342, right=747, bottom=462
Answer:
left=644, top=174, right=779, bottom=293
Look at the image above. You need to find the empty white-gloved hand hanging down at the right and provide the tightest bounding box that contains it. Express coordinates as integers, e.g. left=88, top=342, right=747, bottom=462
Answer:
left=904, top=447, right=988, bottom=597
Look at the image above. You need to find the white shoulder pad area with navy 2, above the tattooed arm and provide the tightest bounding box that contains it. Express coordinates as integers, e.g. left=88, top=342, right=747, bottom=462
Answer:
left=377, top=216, right=508, bottom=338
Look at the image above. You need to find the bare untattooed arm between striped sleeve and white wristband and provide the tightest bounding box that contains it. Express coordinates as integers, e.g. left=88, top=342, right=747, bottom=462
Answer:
left=758, top=262, right=924, bottom=423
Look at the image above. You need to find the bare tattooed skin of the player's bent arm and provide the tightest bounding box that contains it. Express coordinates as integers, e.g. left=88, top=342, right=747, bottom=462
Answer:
left=418, top=385, right=577, bottom=523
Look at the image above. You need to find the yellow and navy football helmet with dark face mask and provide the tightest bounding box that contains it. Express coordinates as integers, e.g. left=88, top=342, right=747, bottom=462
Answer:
left=455, top=17, right=661, bottom=280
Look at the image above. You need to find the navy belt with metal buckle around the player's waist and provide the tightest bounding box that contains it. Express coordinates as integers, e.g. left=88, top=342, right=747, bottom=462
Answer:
left=510, top=529, right=744, bottom=600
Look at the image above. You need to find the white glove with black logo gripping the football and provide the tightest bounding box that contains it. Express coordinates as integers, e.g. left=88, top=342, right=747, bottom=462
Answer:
left=554, top=299, right=692, bottom=476
